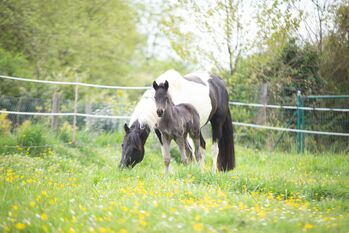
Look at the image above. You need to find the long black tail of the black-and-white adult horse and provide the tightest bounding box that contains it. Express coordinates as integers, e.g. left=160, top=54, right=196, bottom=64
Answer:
left=217, top=110, right=235, bottom=171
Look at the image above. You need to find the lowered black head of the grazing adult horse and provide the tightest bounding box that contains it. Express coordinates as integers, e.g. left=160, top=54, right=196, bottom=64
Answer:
left=119, top=123, right=150, bottom=168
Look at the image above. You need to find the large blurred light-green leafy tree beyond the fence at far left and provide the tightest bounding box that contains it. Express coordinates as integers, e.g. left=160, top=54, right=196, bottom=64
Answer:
left=0, top=0, right=145, bottom=84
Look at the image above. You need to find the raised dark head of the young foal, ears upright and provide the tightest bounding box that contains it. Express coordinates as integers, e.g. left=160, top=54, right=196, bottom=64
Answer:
left=153, top=80, right=170, bottom=117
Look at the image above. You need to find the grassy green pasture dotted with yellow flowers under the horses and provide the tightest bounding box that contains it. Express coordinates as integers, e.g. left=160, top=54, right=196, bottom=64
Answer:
left=0, top=133, right=349, bottom=233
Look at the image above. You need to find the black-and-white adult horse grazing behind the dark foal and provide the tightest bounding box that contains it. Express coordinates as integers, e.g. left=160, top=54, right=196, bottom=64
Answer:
left=119, top=70, right=235, bottom=172
